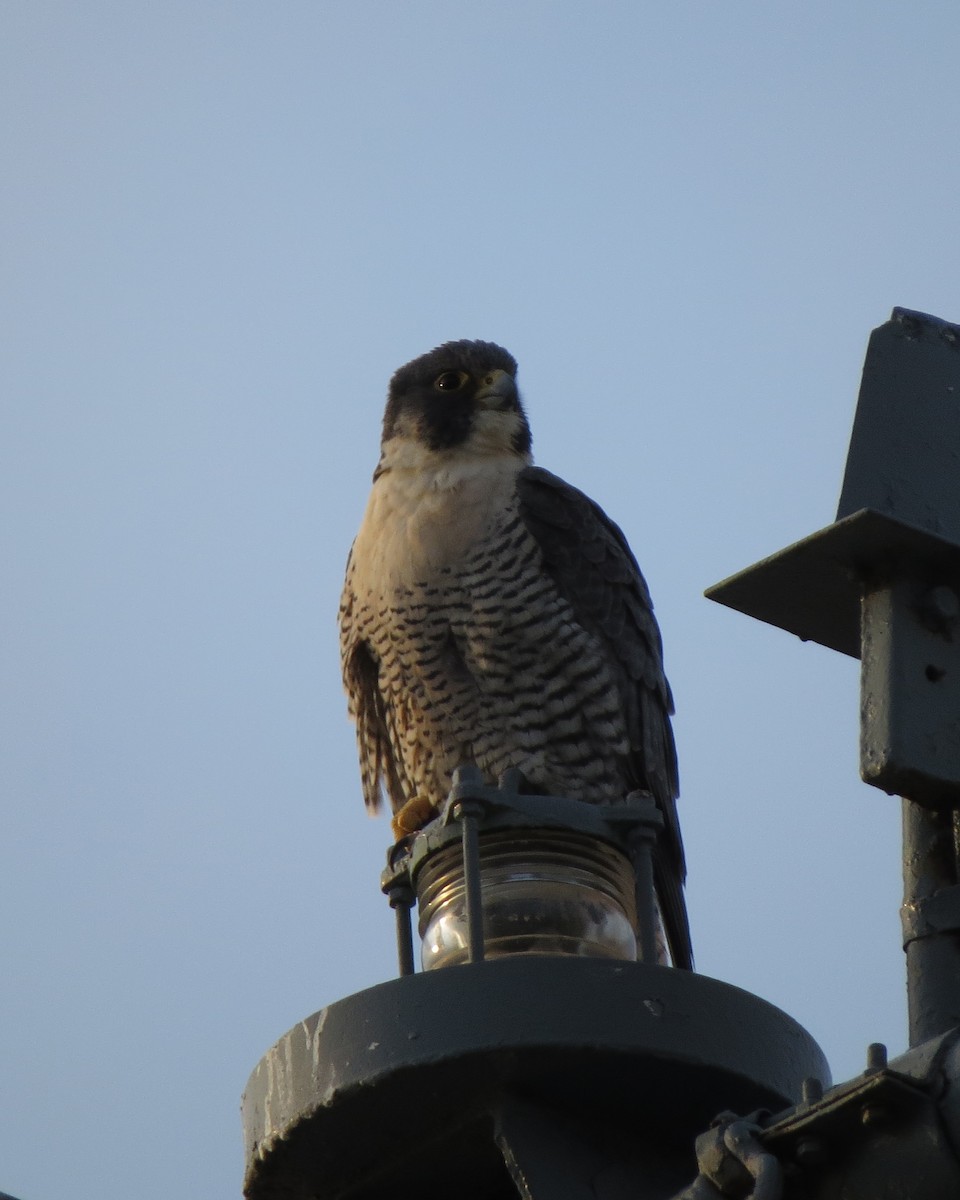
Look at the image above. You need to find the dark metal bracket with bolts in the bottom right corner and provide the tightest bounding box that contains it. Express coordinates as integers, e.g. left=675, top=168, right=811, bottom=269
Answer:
left=676, top=1031, right=960, bottom=1200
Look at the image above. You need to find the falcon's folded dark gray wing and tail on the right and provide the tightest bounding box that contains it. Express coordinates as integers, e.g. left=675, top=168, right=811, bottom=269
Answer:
left=517, top=467, right=692, bottom=968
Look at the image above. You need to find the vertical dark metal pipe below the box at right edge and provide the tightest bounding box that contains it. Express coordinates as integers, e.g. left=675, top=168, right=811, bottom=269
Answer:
left=901, top=799, right=960, bottom=1046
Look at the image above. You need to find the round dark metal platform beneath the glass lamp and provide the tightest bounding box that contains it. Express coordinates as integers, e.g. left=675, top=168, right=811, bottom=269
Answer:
left=242, top=955, right=829, bottom=1200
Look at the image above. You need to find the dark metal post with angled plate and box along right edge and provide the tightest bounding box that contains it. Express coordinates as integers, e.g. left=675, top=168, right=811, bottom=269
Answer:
left=707, top=308, right=960, bottom=1045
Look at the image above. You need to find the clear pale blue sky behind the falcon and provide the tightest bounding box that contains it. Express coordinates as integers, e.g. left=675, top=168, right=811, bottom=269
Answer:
left=0, top=0, right=960, bottom=1200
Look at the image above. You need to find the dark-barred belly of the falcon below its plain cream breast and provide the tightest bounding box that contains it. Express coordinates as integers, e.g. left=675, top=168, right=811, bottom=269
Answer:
left=368, top=506, right=628, bottom=808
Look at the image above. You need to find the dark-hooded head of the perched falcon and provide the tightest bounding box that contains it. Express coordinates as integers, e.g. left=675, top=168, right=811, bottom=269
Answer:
left=383, top=341, right=530, bottom=461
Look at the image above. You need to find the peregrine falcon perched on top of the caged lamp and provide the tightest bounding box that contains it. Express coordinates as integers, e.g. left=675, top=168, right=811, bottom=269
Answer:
left=340, top=341, right=691, bottom=967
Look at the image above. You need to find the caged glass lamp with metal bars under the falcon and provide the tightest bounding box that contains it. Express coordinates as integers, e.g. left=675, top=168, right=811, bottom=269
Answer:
left=382, top=767, right=662, bottom=973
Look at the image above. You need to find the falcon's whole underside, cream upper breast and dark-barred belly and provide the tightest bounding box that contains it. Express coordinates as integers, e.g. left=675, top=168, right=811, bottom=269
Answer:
left=341, top=451, right=629, bottom=825
